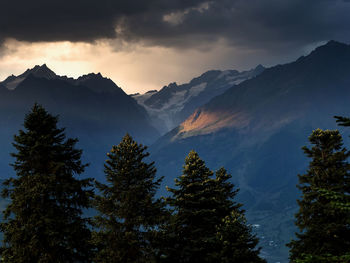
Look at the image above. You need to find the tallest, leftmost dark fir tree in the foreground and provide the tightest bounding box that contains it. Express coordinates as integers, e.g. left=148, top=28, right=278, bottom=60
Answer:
left=0, top=104, right=93, bottom=263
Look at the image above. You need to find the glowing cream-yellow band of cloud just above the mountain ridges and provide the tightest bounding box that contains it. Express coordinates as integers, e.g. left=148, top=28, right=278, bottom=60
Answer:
left=0, top=40, right=284, bottom=93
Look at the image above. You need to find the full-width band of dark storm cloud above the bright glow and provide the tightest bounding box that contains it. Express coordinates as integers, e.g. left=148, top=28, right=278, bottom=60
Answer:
left=0, top=0, right=350, bottom=48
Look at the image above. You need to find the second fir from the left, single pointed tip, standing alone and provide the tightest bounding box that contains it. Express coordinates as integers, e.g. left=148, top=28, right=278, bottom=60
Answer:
left=94, top=134, right=164, bottom=263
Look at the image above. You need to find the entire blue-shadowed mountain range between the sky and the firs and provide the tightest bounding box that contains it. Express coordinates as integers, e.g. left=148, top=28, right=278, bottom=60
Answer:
left=0, top=41, right=350, bottom=263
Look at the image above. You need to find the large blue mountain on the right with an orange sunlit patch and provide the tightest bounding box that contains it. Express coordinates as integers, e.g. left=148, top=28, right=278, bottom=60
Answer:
left=151, top=41, right=350, bottom=262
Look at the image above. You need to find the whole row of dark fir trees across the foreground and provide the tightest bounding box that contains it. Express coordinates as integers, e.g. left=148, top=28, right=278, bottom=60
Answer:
left=0, top=104, right=350, bottom=263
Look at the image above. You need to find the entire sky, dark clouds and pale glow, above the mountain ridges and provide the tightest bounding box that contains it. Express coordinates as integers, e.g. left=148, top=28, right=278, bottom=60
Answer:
left=0, top=0, right=350, bottom=94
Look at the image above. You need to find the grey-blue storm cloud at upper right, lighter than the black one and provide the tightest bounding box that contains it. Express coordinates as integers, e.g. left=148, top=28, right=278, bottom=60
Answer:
left=120, top=0, right=350, bottom=48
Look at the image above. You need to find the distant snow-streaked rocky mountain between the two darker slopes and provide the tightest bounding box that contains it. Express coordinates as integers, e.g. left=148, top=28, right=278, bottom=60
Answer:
left=133, top=65, right=265, bottom=133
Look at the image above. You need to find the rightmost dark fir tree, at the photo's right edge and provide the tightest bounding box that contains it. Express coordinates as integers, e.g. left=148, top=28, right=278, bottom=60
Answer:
left=288, top=129, right=350, bottom=263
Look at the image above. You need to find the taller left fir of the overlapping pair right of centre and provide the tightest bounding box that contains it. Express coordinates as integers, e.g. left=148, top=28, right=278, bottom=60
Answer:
left=164, top=151, right=217, bottom=262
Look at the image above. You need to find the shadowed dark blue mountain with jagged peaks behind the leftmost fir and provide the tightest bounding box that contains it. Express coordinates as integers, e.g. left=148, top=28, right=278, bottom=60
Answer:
left=0, top=65, right=159, bottom=182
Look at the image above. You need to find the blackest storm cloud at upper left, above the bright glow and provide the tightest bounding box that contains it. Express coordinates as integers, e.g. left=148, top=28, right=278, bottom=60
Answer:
left=0, top=0, right=199, bottom=41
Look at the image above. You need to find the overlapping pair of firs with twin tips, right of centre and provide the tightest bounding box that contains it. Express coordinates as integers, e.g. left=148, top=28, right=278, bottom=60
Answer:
left=162, top=151, right=264, bottom=262
